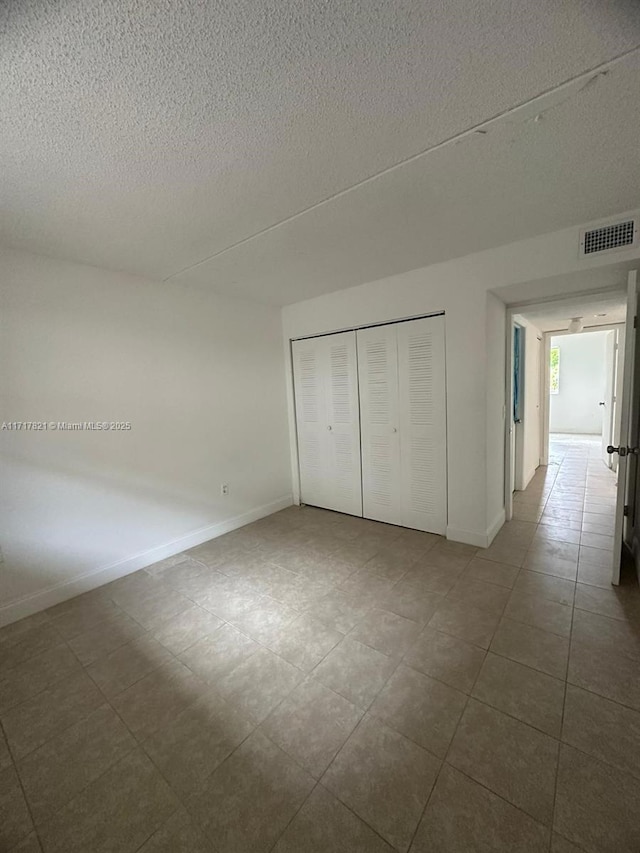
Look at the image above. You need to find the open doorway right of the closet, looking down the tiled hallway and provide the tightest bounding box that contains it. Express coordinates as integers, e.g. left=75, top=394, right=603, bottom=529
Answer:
left=505, top=280, right=640, bottom=585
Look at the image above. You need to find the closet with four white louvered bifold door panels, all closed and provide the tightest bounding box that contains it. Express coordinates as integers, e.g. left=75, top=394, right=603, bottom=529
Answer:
left=292, top=315, right=447, bottom=534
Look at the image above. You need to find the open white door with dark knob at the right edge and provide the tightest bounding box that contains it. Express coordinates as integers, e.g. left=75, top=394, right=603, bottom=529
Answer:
left=611, top=270, right=640, bottom=584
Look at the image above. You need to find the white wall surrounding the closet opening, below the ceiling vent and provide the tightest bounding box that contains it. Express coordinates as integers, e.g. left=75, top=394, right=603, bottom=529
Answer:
left=283, top=210, right=640, bottom=546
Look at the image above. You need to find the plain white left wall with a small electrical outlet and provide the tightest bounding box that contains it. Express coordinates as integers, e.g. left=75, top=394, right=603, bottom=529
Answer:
left=0, top=250, right=291, bottom=623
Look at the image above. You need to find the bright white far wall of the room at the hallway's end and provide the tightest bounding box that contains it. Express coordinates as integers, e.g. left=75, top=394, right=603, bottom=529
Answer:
left=549, top=332, right=607, bottom=435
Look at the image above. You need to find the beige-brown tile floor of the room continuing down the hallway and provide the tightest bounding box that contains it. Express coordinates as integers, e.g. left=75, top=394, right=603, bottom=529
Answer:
left=0, top=438, right=640, bottom=853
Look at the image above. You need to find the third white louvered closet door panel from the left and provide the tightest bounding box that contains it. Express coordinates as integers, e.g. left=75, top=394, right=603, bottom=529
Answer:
left=358, top=325, right=402, bottom=524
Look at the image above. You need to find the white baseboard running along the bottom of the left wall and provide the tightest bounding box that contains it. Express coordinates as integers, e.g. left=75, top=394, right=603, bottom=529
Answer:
left=0, top=495, right=293, bottom=627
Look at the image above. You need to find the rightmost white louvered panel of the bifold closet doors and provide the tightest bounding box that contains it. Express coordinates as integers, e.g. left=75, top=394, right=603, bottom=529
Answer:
left=397, top=316, right=447, bottom=534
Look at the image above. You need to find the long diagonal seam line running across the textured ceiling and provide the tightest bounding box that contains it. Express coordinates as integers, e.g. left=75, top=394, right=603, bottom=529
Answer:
left=162, top=44, right=640, bottom=282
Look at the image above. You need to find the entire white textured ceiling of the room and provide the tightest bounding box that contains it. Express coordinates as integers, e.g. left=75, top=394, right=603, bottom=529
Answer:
left=0, top=0, right=640, bottom=304
